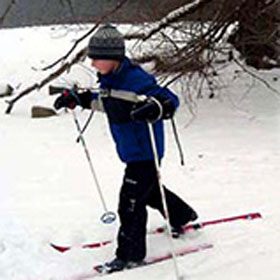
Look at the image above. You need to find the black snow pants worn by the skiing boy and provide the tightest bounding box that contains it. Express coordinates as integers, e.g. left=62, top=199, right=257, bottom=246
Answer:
left=116, top=161, right=196, bottom=261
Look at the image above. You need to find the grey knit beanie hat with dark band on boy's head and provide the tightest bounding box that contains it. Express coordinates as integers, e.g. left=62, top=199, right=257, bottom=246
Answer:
left=87, top=24, right=125, bottom=60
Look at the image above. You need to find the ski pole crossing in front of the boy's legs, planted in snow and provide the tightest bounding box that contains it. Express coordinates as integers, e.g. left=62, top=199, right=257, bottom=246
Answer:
left=147, top=122, right=183, bottom=280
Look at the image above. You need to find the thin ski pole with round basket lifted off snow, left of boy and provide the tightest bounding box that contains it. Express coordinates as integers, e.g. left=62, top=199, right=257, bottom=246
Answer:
left=71, top=110, right=116, bottom=224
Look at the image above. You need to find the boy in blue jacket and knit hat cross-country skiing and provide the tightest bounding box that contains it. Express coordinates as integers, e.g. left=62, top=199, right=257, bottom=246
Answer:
left=54, top=25, right=197, bottom=272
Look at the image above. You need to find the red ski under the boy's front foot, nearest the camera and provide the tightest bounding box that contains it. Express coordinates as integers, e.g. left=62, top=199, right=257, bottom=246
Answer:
left=73, top=243, right=214, bottom=280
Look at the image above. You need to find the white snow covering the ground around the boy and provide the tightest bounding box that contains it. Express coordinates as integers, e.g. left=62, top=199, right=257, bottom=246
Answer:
left=0, top=27, right=280, bottom=280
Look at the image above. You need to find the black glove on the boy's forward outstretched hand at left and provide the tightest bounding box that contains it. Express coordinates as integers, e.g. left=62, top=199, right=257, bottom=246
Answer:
left=54, top=89, right=92, bottom=110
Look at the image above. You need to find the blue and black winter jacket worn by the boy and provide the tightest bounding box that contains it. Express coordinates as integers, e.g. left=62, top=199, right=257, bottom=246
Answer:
left=93, top=58, right=179, bottom=163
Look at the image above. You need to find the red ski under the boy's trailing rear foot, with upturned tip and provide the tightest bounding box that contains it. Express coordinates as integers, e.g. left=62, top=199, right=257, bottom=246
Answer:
left=50, top=212, right=262, bottom=253
